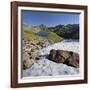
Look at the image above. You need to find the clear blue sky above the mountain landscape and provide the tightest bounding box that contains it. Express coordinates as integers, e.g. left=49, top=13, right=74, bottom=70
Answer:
left=21, top=10, right=79, bottom=26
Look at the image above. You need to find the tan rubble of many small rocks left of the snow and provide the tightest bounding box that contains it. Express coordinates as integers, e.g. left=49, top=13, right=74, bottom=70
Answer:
left=22, top=39, right=49, bottom=70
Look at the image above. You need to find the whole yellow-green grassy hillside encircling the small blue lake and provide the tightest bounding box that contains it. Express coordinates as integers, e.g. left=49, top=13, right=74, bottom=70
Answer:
left=23, top=24, right=63, bottom=42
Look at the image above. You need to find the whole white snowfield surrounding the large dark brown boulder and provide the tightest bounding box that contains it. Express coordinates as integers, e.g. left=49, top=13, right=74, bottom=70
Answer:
left=23, top=41, right=79, bottom=77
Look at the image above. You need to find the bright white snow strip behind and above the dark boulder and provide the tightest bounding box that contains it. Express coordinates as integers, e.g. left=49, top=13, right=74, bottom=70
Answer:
left=40, top=41, right=79, bottom=55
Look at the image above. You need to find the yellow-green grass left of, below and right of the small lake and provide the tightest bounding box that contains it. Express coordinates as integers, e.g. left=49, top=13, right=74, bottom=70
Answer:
left=23, top=25, right=63, bottom=42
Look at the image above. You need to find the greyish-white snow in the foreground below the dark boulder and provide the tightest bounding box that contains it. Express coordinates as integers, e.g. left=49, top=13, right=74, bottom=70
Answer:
left=23, top=59, right=79, bottom=77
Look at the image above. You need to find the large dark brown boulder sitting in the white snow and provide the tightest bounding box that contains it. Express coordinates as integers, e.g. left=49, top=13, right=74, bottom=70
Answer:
left=48, top=49, right=79, bottom=68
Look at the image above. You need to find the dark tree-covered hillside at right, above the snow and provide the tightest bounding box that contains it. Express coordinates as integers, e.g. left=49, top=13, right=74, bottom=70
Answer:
left=48, top=24, right=79, bottom=39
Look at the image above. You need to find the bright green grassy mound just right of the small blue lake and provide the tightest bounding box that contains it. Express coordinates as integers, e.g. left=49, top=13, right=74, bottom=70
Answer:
left=47, top=32, right=63, bottom=42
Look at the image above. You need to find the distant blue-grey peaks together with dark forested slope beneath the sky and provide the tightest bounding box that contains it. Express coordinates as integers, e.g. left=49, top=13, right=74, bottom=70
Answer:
left=30, top=24, right=79, bottom=39
